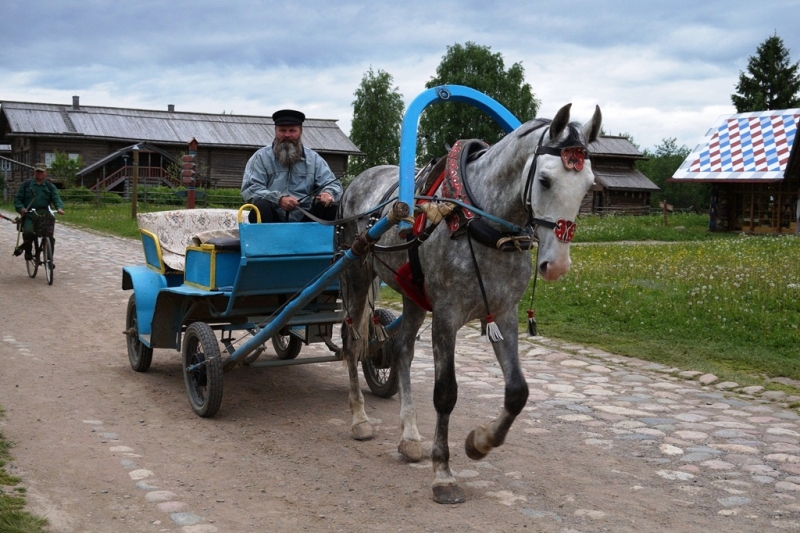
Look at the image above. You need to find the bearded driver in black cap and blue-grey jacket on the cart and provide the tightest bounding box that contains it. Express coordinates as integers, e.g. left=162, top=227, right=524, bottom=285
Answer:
left=242, top=109, right=342, bottom=222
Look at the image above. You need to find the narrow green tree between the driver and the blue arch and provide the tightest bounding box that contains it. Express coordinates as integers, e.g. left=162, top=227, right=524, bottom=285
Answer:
left=349, top=68, right=405, bottom=176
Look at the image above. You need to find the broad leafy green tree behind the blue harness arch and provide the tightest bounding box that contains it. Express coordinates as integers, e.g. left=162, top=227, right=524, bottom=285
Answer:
left=417, top=42, right=541, bottom=164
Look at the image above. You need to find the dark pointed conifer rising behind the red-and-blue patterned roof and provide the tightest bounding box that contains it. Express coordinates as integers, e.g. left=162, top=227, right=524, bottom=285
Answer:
left=731, top=34, right=800, bottom=113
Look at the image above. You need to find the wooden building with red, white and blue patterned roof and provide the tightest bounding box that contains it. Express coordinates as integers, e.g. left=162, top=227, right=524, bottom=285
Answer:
left=670, top=109, right=800, bottom=234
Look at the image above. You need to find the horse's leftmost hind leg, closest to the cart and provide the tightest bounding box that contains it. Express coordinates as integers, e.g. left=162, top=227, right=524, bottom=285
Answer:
left=341, top=268, right=375, bottom=440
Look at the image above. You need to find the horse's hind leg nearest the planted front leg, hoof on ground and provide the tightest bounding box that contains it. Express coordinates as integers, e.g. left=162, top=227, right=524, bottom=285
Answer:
left=397, top=298, right=425, bottom=463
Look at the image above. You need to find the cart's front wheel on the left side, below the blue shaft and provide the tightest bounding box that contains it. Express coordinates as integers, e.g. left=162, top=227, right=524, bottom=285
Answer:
left=183, top=322, right=222, bottom=418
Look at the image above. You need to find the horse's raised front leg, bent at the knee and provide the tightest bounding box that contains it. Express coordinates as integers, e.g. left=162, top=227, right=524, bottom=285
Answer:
left=465, top=309, right=528, bottom=461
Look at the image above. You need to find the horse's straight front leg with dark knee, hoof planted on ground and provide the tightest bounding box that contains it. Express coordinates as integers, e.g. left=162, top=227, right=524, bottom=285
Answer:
left=431, top=312, right=464, bottom=503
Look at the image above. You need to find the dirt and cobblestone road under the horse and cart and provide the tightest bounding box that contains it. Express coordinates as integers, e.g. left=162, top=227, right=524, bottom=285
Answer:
left=0, top=213, right=800, bottom=533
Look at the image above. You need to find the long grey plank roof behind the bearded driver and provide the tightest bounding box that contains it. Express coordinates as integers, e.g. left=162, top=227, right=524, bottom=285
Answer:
left=0, top=101, right=361, bottom=155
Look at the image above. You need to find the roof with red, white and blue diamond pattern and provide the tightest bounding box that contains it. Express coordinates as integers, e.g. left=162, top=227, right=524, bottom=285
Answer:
left=670, top=109, right=800, bottom=182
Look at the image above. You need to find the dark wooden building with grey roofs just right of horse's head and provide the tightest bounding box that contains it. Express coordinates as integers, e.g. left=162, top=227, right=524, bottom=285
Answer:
left=581, top=135, right=660, bottom=215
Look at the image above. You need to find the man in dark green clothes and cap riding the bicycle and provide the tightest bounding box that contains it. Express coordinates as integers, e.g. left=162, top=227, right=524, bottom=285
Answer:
left=14, top=163, right=64, bottom=259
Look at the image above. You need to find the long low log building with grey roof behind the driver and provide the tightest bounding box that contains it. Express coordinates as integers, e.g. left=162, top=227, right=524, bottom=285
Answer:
left=0, top=96, right=363, bottom=192
